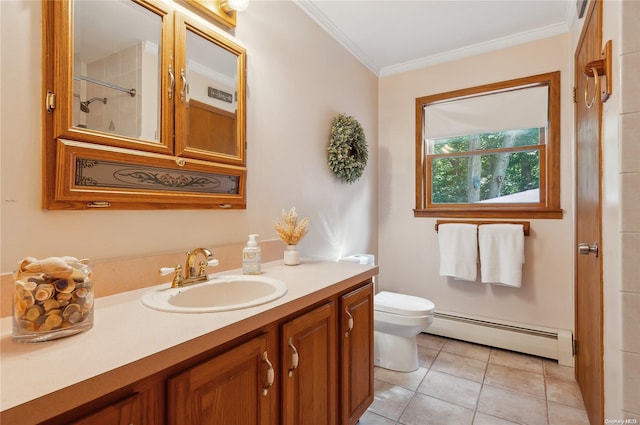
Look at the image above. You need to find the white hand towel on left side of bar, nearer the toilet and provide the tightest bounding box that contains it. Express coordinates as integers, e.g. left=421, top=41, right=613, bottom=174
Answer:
left=438, top=223, right=478, bottom=281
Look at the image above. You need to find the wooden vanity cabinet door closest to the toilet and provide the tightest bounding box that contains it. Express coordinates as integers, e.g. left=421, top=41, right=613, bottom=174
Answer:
left=340, top=283, right=373, bottom=425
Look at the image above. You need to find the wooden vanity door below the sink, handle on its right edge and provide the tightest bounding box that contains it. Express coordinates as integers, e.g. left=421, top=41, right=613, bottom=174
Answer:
left=167, top=335, right=276, bottom=425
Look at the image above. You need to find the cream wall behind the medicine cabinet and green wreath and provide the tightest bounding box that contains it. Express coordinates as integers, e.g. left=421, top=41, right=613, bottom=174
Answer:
left=0, top=0, right=378, bottom=273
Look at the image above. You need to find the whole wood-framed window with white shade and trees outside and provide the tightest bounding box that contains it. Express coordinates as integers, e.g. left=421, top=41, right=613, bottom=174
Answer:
left=414, top=71, right=562, bottom=218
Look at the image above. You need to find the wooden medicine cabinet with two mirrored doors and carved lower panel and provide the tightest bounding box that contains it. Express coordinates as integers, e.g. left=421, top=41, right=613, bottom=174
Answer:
left=42, top=0, right=247, bottom=209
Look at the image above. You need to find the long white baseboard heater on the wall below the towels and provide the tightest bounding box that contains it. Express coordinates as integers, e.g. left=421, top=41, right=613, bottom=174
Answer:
left=425, top=311, right=573, bottom=367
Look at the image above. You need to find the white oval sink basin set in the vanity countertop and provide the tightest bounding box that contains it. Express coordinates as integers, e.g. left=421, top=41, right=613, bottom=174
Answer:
left=142, top=275, right=287, bottom=313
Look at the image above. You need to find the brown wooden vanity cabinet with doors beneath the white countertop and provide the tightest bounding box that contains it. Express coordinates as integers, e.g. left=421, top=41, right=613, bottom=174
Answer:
left=28, top=280, right=373, bottom=425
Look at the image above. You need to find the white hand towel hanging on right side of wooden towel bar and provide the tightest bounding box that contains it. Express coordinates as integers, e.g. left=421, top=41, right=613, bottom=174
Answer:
left=478, top=224, right=524, bottom=288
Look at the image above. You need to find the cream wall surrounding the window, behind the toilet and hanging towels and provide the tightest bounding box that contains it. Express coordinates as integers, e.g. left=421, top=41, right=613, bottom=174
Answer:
left=378, top=35, right=574, bottom=329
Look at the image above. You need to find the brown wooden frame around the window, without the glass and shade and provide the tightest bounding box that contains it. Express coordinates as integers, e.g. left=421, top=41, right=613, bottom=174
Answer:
left=413, top=71, right=563, bottom=219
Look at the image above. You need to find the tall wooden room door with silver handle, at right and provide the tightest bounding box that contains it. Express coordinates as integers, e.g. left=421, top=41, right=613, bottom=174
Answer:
left=575, top=0, right=604, bottom=425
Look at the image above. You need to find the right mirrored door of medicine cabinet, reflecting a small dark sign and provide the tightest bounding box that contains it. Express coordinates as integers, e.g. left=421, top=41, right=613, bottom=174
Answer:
left=176, top=14, right=245, bottom=164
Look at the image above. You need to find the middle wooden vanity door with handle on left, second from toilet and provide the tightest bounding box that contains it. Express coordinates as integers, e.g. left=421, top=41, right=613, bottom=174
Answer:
left=281, top=302, right=337, bottom=425
